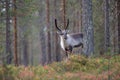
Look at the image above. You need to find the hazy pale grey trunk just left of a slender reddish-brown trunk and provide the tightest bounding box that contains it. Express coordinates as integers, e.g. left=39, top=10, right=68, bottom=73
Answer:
left=37, top=0, right=48, bottom=65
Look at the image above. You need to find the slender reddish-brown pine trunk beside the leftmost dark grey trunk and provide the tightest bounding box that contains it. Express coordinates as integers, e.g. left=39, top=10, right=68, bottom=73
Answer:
left=13, top=0, right=18, bottom=66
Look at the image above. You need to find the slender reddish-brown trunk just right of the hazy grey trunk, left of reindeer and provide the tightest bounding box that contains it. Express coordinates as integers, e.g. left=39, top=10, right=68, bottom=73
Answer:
left=46, top=0, right=51, bottom=63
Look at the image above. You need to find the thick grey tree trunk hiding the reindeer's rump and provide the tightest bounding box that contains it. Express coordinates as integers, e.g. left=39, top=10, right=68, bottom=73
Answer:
left=82, top=0, right=94, bottom=56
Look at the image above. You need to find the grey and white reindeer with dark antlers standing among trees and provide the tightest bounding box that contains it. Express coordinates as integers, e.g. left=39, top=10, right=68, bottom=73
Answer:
left=55, top=19, right=83, bottom=57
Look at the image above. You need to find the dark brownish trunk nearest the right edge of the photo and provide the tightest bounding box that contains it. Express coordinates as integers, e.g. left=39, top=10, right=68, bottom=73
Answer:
left=110, top=0, right=118, bottom=53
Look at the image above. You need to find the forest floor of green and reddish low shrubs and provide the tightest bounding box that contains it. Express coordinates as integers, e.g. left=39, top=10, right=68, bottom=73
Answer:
left=0, top=55, right=120, bottom=80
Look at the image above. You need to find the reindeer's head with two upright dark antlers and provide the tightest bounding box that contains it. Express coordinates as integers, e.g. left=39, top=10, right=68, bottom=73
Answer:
left=55, top=19, right=69, bottom=39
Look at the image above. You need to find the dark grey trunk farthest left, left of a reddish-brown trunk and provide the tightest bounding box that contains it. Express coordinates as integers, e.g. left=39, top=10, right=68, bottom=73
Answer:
left=6, top=0, right=12, bottom=64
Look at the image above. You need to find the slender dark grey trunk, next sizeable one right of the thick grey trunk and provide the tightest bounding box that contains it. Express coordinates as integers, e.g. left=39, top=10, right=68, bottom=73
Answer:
left=104, top=0, right=110, bottom=52
